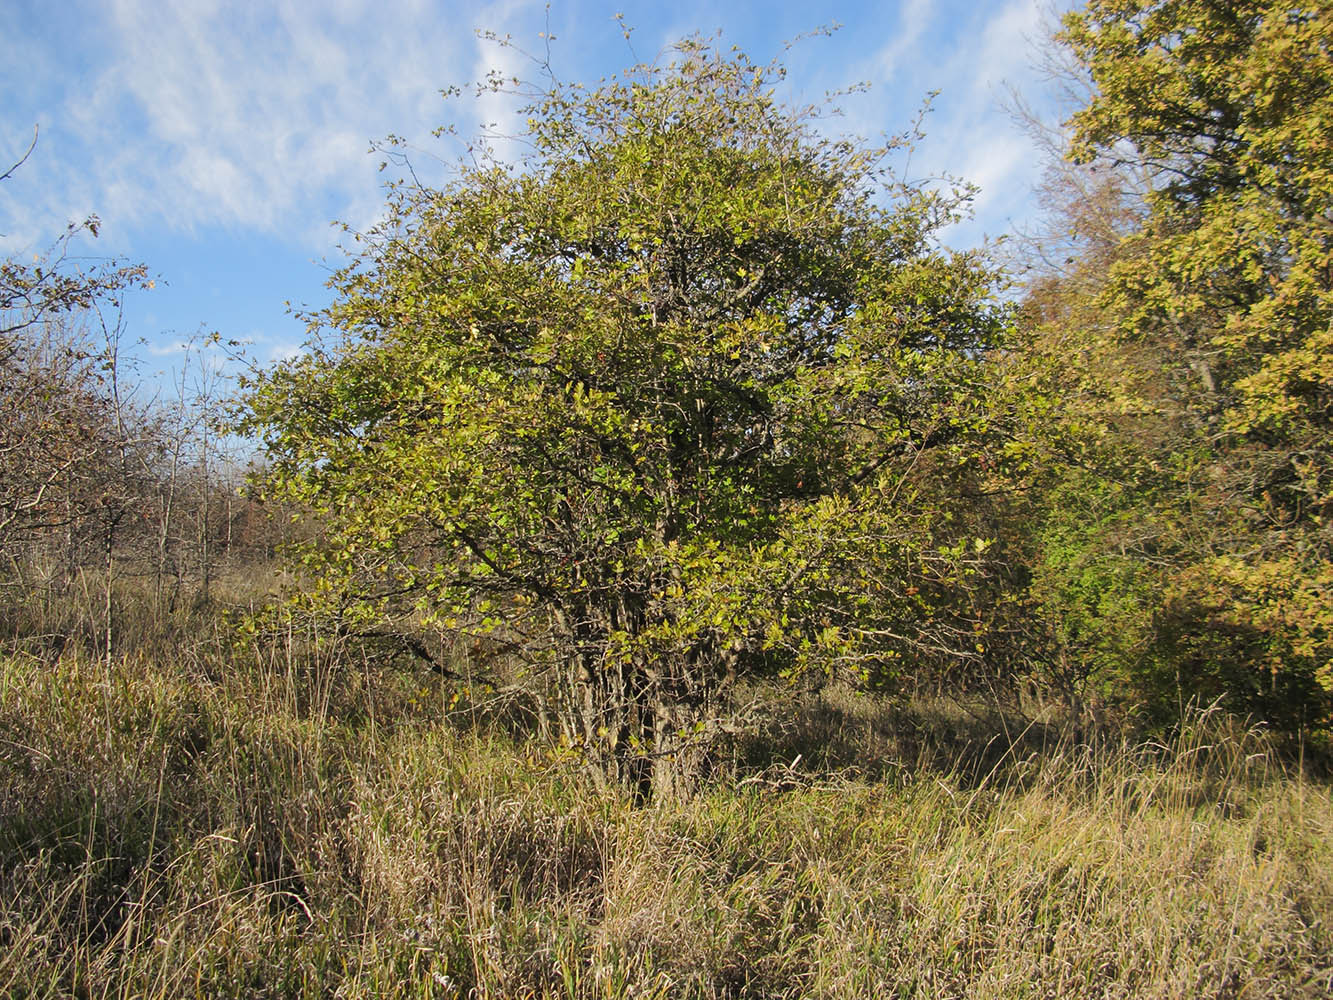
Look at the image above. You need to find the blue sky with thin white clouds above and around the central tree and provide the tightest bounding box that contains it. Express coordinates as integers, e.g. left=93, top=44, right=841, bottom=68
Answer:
left=0, top=0, right=1068, bottom=369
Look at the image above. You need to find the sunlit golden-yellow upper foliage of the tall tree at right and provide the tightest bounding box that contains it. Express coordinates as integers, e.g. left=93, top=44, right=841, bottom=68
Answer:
left=1064, top=0, right=1333, bottom=445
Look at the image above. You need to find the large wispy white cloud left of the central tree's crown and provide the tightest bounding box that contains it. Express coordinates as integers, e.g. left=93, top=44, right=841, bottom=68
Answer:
left=0, top=0, right=546, bottom=245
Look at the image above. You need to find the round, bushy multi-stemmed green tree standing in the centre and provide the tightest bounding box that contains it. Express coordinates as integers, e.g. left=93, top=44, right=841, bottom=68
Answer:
left=243, top=40, right=1008, bottom=792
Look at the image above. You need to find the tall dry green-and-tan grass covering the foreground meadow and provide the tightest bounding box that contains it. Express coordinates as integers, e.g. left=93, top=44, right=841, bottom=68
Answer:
left=0, top=578, right=1333, bottom=997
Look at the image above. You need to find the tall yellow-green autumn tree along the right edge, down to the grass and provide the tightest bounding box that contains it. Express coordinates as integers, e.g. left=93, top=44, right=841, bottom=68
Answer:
left=1007, top=0, right=1333, bottom=725
